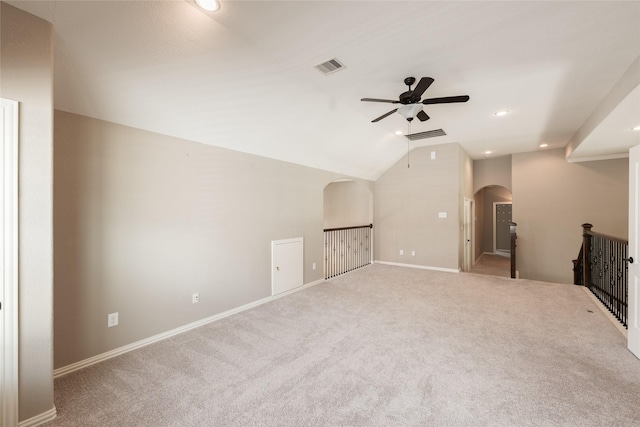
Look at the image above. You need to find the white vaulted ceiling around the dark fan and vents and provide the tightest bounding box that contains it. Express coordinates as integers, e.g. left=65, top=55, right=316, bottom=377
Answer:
left=8, top=0, right=640, bottom=179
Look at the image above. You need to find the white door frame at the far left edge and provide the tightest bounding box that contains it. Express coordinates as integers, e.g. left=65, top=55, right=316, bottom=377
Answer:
left=0, top=98, right=19, bottom=426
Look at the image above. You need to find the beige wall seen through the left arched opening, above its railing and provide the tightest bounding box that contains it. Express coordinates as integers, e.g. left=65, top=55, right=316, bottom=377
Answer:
left=324, top=181, right=373, bottom=228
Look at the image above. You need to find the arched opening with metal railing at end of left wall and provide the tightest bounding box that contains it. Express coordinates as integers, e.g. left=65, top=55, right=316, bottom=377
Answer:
left=323, top=179, right=373, bottom=279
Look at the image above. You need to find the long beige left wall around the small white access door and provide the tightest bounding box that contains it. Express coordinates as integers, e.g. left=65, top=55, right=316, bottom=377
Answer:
left=54, top=111, right=362, bottom=368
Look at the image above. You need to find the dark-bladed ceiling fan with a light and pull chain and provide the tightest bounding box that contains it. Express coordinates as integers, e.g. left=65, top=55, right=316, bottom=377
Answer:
left=360, top=77, right=469, bottom=123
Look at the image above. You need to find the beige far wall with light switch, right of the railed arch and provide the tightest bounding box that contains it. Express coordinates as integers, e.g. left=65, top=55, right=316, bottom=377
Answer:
left=374, top=144, right=464, bottom=270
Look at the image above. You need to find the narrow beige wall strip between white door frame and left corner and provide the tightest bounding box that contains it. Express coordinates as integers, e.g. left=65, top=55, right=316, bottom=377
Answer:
left=0, top=3, right=53, bottom=420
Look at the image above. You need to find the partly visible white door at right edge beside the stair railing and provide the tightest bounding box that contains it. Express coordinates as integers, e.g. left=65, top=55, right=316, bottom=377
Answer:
left=627, top=145, right=640, bottom=358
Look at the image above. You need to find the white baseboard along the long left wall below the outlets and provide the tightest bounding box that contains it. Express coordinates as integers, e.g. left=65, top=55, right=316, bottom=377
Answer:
left=54, top=279, right=325, bottom=380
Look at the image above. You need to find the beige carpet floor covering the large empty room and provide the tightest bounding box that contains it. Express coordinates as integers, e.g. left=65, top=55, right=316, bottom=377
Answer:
left=47, top=265, right=640, bottom=426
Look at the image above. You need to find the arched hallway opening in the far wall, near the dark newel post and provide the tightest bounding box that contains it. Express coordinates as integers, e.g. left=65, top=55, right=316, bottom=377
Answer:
left=472, top=185, right=513, bottom=276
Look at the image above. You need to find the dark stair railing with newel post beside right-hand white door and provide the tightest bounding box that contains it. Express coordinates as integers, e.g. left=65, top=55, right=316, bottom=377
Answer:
left=573, top=224, right=633, bottom=328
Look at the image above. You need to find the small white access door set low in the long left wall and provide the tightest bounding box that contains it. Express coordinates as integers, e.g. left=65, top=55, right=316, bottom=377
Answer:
left=271, top=237, right=304, bottom=295
